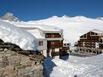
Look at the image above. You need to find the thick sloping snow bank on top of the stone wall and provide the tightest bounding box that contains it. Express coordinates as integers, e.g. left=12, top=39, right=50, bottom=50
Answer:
left=0, top=20, right=37, bottom=50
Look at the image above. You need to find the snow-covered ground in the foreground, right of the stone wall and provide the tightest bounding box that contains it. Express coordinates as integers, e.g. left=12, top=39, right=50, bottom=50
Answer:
left=44, top=54, right=103, bottom=77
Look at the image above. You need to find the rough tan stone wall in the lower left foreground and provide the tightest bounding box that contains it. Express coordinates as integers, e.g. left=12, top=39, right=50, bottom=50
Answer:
left=0, top=49, right=44, bottom=77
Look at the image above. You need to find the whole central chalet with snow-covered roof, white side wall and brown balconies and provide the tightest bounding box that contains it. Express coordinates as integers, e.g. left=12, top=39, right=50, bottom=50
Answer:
left=16, top=24, right=69, bottom=57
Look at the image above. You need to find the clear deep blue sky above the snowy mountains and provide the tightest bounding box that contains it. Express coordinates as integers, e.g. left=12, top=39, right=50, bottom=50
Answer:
left=0, top=0, right=103, bottom=21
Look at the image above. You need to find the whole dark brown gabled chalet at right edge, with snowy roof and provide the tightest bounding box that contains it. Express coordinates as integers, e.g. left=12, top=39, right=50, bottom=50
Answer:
left=75, top=29, right=103, bottom=54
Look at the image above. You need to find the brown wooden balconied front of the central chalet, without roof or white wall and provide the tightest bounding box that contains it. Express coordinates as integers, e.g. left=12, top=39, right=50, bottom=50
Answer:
left=45, top=33, right=67, bottom=57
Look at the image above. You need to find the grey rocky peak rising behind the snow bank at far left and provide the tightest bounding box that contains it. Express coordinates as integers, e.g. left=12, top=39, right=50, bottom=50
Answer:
left=0, top=12, right=19, bottom=21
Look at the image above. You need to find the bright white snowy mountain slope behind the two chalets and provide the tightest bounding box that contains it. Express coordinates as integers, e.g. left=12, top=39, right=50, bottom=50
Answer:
left=28, top=16, right=103, bottom=43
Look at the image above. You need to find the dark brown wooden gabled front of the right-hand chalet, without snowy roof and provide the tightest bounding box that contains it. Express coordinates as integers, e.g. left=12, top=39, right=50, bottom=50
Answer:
left=77, top=32, right=100, bottom=48
